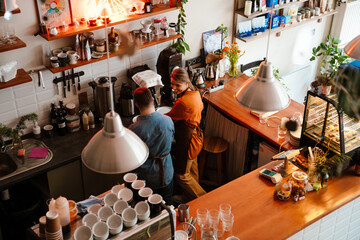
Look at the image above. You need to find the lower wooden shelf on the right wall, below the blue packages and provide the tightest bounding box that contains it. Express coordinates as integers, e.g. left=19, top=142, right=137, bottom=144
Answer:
left=235, top=10, right=337, bottom=43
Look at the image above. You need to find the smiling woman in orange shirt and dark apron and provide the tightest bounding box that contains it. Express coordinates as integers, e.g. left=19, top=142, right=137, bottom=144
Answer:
left=167, top=68, right=206, bottom=201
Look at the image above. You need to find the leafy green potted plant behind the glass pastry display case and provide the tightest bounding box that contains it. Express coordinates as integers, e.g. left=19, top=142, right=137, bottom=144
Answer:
left=310, top=34, right=349, bottom=95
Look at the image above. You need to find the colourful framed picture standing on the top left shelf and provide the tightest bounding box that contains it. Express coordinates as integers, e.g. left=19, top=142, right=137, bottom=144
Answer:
left=36, top=0, right=72, bottom=27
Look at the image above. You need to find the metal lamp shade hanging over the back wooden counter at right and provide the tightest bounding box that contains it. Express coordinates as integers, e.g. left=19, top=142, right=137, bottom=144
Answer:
left=235, top=61, right=290, bottom=112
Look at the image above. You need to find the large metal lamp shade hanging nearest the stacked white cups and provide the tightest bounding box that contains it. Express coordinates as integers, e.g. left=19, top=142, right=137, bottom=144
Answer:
left=81, top=111, right=149, bottom=174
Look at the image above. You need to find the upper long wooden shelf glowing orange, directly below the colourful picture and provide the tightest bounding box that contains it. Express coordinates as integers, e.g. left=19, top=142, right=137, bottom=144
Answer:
left=41, top=6, right=177, bottom=41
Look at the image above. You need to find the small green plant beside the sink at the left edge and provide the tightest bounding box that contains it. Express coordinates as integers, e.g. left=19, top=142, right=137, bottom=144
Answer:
left=0, top=113, right=38, bottom=149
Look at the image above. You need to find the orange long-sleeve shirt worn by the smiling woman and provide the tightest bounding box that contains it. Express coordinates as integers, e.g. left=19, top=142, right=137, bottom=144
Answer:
left=166, top=91, right=204, bottom=159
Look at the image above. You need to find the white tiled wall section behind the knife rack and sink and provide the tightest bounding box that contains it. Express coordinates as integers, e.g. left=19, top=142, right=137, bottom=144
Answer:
left=0, top=42, right=171, bottom=133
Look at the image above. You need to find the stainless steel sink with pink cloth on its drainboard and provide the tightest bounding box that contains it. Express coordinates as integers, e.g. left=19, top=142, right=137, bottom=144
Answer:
left=0, top=139, right=53, bottom=180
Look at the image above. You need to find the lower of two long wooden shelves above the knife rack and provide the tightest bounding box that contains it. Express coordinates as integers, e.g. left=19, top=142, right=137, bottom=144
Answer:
left=47, top=34, right=181, bottom=73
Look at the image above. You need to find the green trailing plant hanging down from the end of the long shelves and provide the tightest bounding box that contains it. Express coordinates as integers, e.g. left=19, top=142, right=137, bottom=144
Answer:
left=170, top=0, right=190, bottom=54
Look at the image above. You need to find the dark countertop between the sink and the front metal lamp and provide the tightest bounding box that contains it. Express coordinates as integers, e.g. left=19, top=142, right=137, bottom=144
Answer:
left=0, top=124, right=101, bottom=190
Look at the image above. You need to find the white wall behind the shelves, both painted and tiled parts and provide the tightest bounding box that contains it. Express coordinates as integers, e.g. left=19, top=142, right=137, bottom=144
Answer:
left=0, top=0, right=331, bottom=132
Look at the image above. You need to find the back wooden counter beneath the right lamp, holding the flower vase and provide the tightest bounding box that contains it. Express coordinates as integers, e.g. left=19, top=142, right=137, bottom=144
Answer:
left=204, top=75, right=304, bottom=149
